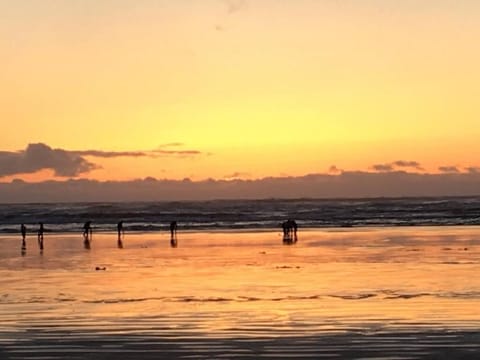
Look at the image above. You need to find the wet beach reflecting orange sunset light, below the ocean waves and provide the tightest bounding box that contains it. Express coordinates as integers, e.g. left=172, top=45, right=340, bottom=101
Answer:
left=0, top=226, right=480, bottom=359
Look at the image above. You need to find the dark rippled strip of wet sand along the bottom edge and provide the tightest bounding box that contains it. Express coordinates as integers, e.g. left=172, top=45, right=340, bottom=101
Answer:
left=0, top=331, right=480, bottom=360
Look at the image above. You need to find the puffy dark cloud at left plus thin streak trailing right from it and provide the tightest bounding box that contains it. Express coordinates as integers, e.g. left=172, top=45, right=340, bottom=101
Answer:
left=0, top=143, right=202, bottom=178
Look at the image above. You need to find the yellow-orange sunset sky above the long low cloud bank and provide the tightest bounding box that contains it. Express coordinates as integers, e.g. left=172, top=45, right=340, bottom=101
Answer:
left=0, top=0, right=480, bottom=200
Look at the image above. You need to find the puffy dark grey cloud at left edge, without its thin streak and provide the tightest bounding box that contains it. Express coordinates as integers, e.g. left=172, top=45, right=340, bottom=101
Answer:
left=0, top=143, right=98, bottom=177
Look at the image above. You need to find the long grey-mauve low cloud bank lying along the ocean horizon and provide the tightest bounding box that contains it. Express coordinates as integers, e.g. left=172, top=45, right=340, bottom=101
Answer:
left=0, top=171, right=480, bottom=203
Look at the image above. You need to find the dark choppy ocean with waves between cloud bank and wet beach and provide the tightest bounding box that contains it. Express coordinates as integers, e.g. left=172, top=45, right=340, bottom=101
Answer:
left=0, top=197, right=480, bottom=233
